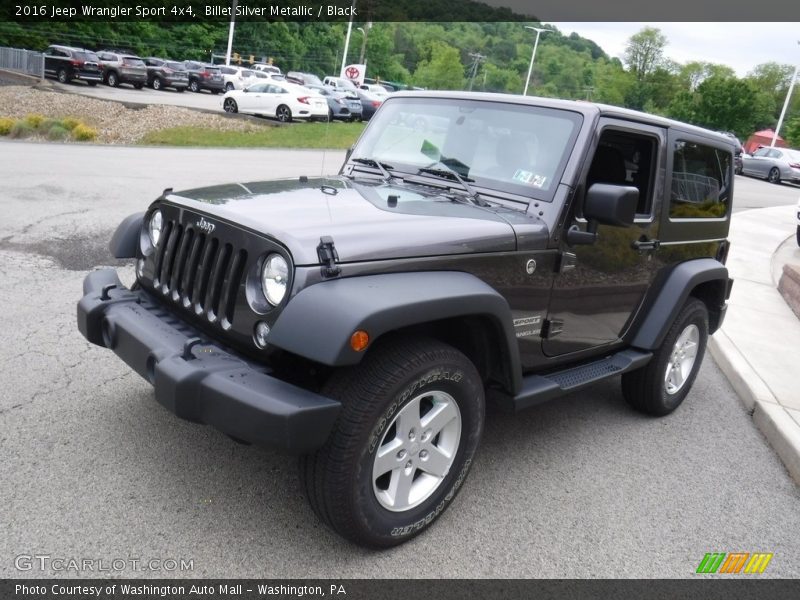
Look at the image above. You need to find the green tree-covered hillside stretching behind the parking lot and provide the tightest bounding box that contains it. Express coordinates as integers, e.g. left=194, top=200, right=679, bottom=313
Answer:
left=0, top=21, right=800, bottom=146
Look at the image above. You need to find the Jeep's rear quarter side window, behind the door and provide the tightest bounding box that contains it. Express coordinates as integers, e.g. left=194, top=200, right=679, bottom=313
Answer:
left=669, top=140, right=731, bottom=219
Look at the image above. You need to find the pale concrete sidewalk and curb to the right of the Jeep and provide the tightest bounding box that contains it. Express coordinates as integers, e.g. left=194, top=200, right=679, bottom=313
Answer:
left=708, top=205, right=800, bottom=484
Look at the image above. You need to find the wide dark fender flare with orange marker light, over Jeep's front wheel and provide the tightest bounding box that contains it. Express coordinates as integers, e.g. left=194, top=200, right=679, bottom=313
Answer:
left=269, top=271, right=522, bottom=393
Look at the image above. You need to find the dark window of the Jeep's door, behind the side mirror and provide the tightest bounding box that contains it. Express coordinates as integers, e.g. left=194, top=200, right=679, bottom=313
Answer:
left=586, top=129, right=658, bottom=218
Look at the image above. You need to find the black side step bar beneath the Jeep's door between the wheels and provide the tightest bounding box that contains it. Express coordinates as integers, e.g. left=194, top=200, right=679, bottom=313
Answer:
left=488, top=350, right=653, bottom=412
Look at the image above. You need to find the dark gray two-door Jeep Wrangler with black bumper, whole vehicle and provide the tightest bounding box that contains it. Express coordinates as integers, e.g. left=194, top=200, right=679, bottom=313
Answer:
left=78, top=92, right=734, bottom=547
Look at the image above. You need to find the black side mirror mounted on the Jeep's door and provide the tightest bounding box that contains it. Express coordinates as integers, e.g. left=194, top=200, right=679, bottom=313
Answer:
left=567, top=183, right=639, bottom=246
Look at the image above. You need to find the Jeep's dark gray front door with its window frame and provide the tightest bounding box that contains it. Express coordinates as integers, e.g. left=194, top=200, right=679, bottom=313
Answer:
left=542, top=118, right=666, bottom=357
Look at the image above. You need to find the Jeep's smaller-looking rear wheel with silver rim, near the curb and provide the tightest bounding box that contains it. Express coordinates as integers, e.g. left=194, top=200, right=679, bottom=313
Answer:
left=622, top=298, right=708, bottom=416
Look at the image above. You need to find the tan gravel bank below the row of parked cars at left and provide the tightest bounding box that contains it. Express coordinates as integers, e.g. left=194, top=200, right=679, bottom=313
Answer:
left=0, top=85, right=270, bottom=144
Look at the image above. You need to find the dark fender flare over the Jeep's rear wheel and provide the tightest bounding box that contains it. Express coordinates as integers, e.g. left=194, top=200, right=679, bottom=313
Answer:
left=631, top=258, right=732, bottom=350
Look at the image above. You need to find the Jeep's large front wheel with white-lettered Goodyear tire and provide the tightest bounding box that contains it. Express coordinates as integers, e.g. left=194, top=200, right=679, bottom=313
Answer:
left=300, top=337, right=485, bottom=548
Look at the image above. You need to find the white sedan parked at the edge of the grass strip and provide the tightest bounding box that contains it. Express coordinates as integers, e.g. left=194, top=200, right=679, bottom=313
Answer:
left=222, top=81, right=328, bottom=123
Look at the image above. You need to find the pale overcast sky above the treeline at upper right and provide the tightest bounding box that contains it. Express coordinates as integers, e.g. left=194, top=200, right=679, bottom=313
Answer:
left=552, top=22, right=800, bottom=77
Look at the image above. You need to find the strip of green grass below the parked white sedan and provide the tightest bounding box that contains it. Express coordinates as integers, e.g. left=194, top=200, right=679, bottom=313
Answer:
left=139, top=123, right=365, bottom=149
